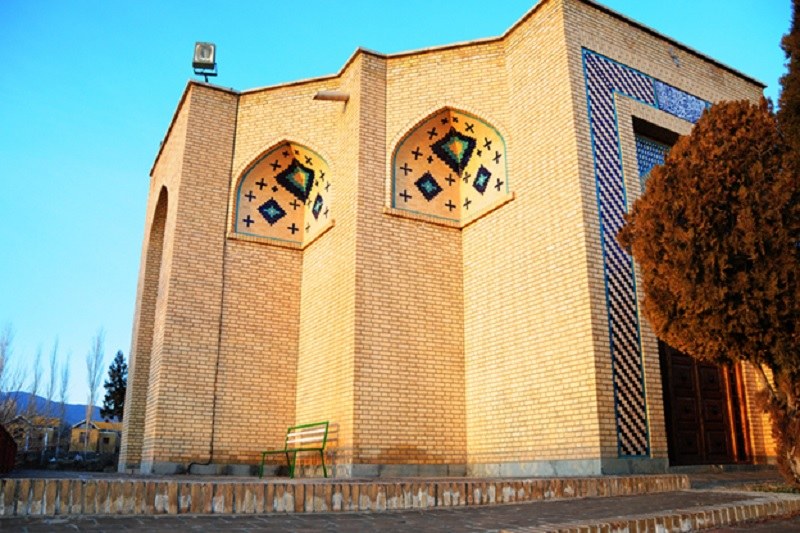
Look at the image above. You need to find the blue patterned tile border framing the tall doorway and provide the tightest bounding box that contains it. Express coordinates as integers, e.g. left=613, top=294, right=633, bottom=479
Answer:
left=583, top=49, right=706, bottom=457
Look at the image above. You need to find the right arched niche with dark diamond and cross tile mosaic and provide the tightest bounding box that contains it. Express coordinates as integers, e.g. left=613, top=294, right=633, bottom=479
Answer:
left=391, top=107, right=510, bottom=226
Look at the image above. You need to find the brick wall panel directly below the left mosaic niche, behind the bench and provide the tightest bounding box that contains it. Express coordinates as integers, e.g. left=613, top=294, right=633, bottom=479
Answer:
left=214, top=239, right=302, bottom=464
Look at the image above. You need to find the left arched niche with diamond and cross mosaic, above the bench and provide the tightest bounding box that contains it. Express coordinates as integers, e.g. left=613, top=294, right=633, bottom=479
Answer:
left=234, top=142, right=332, bottom=245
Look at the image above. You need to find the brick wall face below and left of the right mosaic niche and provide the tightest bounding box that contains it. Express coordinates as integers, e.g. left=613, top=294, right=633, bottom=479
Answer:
left=354, top=50, right=466, bottom=464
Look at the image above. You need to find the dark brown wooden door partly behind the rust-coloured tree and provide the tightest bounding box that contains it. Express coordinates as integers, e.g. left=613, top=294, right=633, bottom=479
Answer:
left=659, top=343, right=746, bottom=465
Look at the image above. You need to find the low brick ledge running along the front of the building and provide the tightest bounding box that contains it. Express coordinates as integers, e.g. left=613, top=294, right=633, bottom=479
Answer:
left=0, top=475, right=689, bottom=525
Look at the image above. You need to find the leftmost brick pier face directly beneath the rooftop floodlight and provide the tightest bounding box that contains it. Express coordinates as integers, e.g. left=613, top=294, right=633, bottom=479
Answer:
left=142, top=85, right=236, bottom=464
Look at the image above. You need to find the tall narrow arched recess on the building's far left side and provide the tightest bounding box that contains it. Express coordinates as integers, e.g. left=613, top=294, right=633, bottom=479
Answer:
left=120, top=187, right=169, bottom=468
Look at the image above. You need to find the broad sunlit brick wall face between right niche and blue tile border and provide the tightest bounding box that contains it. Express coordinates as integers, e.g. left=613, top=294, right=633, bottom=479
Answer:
left=464, top=2, right=599, bottom=463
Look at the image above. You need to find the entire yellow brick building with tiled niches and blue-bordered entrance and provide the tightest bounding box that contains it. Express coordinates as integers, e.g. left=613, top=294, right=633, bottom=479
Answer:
left=120, top=0, right=774, bottom=476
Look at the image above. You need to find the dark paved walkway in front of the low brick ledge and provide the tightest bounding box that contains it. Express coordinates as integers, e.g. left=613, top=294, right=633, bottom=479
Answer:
left=0, top=491, right=797, bottom=533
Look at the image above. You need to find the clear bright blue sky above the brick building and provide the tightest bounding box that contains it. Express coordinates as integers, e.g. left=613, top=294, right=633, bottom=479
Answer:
left=0, top=0, right=790, bottom=403
